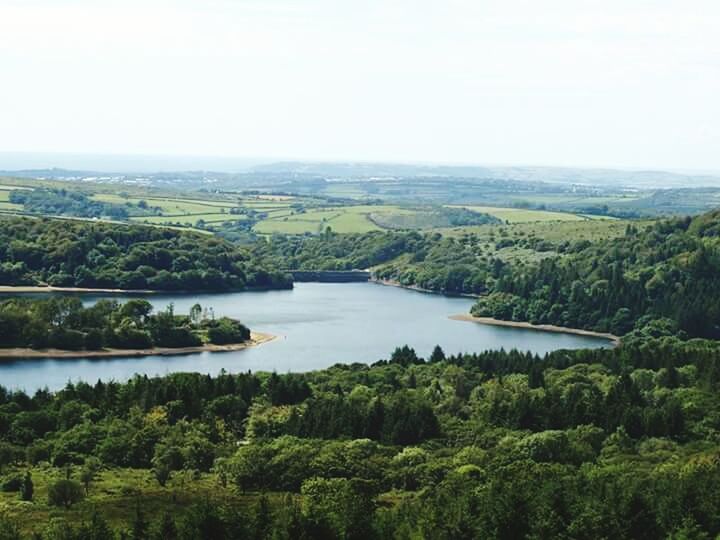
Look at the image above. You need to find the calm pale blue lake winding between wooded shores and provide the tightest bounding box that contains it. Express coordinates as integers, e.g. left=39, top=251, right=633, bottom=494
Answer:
left=0, top=283, right=609, bottom=392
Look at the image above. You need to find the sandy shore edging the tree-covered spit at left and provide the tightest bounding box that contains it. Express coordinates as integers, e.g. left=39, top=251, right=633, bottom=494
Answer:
left=0, top=332, right=277, bottom=360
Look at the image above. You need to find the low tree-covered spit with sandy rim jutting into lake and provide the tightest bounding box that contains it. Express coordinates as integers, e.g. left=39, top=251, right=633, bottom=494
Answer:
left=0, top=297, right=274, bottom=358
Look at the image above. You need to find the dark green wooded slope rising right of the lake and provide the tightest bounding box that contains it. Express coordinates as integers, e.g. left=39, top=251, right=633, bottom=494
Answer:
left=473, top=211, right=720, bottom=338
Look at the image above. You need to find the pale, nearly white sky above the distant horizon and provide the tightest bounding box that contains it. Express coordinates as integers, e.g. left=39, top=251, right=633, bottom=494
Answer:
left=0, top=0, right=720, bottom=171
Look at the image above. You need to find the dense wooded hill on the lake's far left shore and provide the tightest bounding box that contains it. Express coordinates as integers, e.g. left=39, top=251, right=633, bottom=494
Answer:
left=0, top=218, right=292, bottom=291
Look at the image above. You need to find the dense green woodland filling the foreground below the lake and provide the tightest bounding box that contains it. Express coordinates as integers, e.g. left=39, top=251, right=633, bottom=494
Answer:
left=0, top=337, right=720, bottom=540
